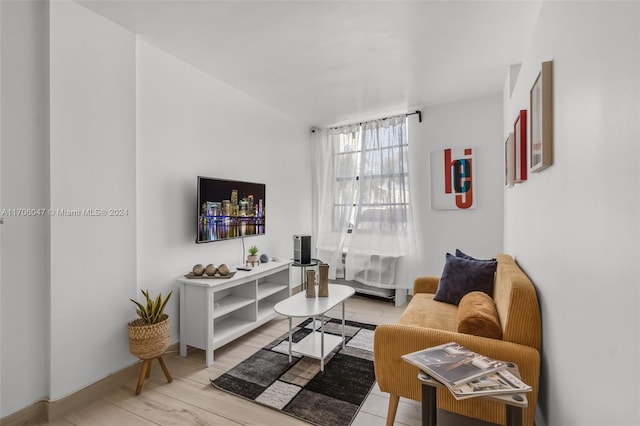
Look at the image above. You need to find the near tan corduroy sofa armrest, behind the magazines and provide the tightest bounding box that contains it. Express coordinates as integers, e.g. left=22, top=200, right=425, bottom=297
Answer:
left=373, top=324, right=540, bottom=424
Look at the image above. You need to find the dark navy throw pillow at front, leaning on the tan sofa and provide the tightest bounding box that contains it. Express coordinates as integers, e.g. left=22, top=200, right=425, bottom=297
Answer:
left=434, top=253, right=498, bottom=305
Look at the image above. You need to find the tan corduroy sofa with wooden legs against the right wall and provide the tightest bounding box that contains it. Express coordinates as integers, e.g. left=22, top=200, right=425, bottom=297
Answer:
left=374, top=254, right=541, bottom=425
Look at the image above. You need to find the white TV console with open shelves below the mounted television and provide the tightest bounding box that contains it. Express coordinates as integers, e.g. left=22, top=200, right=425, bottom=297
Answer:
left=178, top=260, right=292, bottom=367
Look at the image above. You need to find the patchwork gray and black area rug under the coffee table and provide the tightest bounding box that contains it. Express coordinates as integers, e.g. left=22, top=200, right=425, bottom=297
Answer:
left=211, top=317, right=375, bottom=426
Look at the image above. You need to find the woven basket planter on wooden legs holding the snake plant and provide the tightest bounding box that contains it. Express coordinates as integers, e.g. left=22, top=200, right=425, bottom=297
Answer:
left=127, top=314, right=170, bottom=359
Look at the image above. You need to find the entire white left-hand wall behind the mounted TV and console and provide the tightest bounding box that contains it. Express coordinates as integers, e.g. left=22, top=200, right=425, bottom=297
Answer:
left=0, top=0, right=311, bottom=417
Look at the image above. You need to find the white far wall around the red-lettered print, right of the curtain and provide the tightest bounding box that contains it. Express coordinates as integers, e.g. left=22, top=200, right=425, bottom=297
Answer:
left=409, top=94, right=504, bottom=280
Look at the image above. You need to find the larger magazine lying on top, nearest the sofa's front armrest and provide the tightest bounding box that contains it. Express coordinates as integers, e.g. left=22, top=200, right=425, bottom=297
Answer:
left=402, top=342, right=507, bottom=388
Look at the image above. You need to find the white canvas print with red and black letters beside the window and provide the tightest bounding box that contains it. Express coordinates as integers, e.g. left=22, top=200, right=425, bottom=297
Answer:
left=430, top=147, right=476, bottom=210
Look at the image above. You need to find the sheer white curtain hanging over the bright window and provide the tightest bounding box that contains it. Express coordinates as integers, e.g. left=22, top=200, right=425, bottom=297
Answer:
left=311, top=115, right=415, bottom=288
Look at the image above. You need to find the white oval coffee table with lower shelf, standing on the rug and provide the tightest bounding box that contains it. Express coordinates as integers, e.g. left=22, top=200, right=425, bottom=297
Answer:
left=273, top=284, right=355, bottom=371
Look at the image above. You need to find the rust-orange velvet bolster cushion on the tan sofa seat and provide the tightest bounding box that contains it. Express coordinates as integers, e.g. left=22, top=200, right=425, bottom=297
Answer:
left=457, top=291, right=502, bottom=340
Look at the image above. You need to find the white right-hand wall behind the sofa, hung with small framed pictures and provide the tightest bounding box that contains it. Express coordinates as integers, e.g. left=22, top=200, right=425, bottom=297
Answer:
left=504, top=2, right=640, bottom=426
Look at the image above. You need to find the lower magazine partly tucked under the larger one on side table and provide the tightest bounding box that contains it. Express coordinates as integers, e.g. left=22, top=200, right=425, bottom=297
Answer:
left=449, top=370, right=531, bottom=400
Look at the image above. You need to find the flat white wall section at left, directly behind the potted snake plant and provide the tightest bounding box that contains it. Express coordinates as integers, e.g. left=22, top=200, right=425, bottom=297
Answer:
left=49, top=1, right=136, bottom=400
